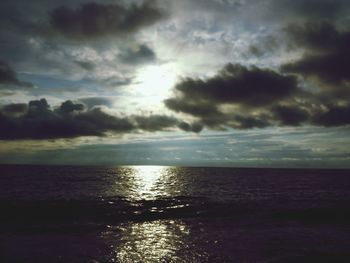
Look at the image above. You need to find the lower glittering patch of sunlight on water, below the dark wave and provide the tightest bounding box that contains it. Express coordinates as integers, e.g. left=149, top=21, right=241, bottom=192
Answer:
left=104, top=220, right=197, bottom=263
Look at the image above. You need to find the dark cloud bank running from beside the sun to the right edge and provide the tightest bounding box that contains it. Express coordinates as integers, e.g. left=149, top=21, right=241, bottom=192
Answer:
left=164, top=64, right=350, bottom=131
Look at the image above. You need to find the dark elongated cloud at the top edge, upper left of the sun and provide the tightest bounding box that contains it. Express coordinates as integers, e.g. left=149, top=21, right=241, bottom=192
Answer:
left=50, top=1, right=164, bottom=39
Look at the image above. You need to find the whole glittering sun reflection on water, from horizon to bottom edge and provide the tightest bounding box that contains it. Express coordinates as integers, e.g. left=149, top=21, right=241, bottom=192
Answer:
left=102, top=166, right=208, bottom=263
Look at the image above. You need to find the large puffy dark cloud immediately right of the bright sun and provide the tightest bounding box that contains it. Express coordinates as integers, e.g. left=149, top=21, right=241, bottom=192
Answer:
left=164, top=64, right=300, bottom=130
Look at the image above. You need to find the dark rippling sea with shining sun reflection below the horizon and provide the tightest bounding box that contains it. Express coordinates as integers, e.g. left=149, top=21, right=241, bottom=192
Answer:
left=0, top=166, right=350, bottom=262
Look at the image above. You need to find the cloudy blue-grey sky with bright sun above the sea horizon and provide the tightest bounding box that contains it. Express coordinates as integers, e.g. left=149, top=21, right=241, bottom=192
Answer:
left=0, top=0, right=350, bottom=168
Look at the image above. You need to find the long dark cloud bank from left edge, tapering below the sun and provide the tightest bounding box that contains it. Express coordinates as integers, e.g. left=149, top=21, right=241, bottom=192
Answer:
left=0, top=99, right=201, bottom=140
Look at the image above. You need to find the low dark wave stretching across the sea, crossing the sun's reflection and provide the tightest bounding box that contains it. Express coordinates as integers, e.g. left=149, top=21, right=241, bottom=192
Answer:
left=0, top=196, right=350, bottom=233
